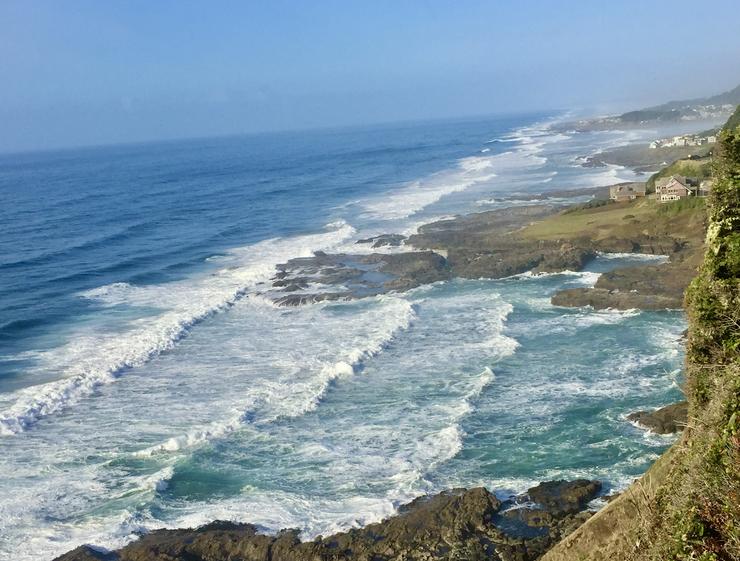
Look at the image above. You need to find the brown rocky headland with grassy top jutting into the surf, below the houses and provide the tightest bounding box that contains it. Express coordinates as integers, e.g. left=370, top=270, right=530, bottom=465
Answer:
left=266, top=187, right=704, bottom=310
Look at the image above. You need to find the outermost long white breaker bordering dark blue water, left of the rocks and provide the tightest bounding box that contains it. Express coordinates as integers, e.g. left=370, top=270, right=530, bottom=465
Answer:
left=0, top=223, right=354, bottom=436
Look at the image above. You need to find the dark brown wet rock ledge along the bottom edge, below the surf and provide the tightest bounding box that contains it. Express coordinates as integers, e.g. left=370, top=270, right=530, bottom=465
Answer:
left=57, top=480, right=601, bottom=561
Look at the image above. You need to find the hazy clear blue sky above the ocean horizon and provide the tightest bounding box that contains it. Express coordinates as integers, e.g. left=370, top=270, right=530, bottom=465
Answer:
left=0, top=0, right=740, bottom=151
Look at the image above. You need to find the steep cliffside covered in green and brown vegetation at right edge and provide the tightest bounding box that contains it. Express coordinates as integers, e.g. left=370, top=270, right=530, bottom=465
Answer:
left=544, top=109, right=740, bottom=561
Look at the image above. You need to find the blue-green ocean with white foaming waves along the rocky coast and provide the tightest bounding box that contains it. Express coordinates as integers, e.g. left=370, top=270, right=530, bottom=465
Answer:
left=0, top=114, right=685, bottom=561
